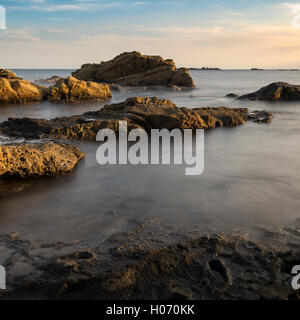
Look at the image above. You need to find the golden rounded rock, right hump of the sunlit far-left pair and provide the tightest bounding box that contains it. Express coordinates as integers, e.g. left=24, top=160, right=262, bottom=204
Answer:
left=48, top=77, right=112, bottom=102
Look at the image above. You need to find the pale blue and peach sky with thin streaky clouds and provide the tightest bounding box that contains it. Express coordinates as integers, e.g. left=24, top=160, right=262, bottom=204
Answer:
left=0, top=0, right=300, bottom=69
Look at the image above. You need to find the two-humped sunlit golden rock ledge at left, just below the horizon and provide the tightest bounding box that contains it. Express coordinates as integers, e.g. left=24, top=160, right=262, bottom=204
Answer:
left=0, top=74, right=112, bottom=104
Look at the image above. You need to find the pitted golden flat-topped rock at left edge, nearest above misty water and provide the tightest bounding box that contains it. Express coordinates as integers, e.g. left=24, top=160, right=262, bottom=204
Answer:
left=0, top=142, right=84, bottom=179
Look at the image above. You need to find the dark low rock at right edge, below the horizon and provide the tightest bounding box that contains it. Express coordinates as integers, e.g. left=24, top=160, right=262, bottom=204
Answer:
left=239, top=82, right=300, bottom=101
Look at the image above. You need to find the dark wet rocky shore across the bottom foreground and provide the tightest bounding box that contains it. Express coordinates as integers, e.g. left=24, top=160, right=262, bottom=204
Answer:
left=0, top=220, right=300, bottom=300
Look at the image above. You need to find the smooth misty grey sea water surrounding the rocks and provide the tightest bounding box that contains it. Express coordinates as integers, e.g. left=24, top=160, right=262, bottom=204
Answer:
left=0, top=70, right=300, bottom=241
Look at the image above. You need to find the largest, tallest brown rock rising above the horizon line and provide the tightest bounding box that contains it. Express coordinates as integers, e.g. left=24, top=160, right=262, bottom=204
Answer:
left=72, top=51, right=194, bottom=87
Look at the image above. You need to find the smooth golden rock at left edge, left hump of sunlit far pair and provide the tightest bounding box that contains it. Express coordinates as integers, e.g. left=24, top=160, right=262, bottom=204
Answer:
left=0, top=78, right=48, bottom=104
